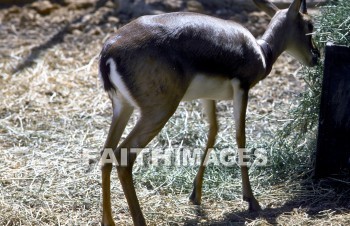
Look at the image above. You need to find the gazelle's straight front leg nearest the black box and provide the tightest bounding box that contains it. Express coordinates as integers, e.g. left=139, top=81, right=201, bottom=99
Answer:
left=233, top=81, right=261, bottom=211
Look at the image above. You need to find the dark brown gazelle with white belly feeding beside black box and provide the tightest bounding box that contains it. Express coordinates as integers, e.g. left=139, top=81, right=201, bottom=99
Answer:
left=99, top=0, right=319, bottom=225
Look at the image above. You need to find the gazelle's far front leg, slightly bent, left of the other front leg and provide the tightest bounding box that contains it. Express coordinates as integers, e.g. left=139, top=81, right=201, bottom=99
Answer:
left=190, top=100, right=218, bottom=205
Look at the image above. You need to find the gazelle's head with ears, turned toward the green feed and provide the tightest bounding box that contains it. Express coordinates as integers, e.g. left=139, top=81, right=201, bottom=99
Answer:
left=254, top=0, right=320, bottom=66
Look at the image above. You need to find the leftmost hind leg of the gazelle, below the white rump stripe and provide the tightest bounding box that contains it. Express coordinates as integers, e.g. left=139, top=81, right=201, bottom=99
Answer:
left=102, top=96, right=133, bottom=225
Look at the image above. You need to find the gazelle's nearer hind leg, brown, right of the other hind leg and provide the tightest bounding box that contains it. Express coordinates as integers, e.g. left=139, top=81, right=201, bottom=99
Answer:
left=115, top=103, right=178, bottom=226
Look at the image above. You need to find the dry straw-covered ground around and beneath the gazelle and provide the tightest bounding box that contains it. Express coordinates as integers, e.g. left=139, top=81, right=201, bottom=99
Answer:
left=0, top=0, right=350, bottom=225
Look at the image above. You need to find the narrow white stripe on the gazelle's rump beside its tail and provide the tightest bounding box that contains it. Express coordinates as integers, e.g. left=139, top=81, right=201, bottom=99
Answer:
left=106, top=58, right=138, bottom=108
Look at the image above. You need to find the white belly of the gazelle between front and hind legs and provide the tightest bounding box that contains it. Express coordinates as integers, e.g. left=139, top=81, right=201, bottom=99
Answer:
left=182, top=74, right=233, bottom=101
